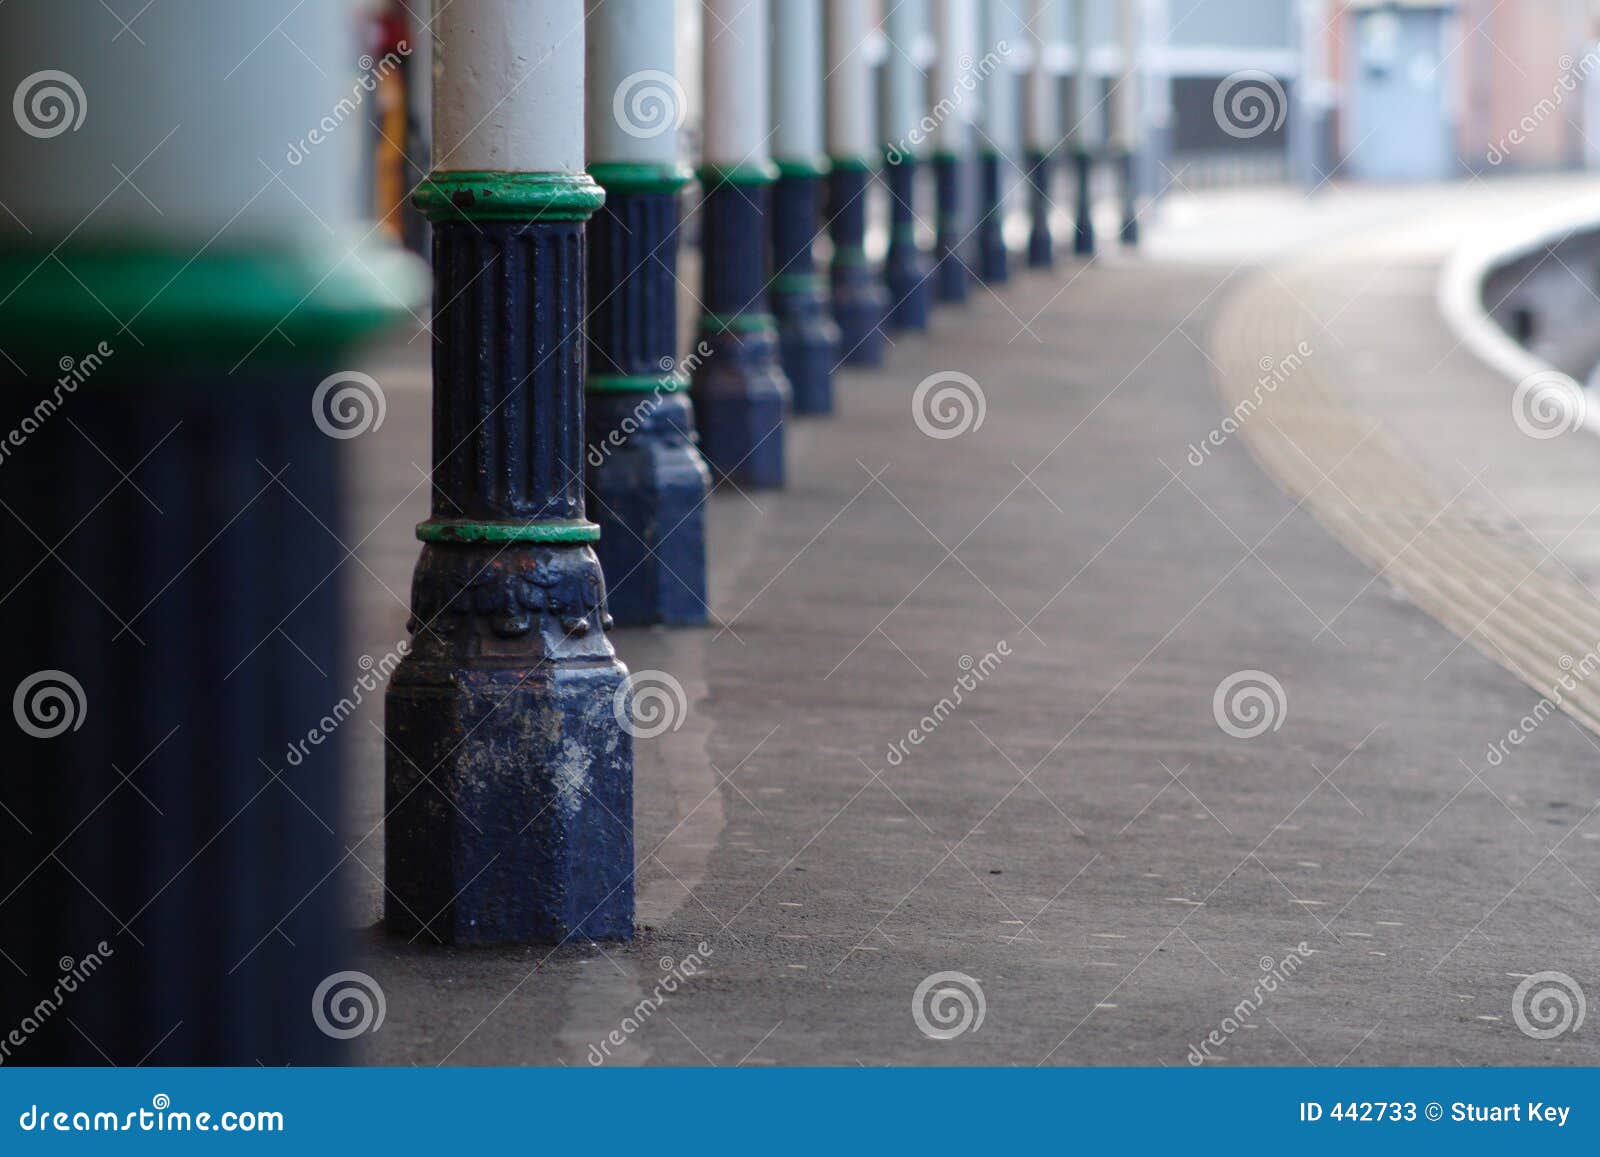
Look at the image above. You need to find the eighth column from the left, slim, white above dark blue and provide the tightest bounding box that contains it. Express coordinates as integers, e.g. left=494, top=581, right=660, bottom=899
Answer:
left=928, top=0, right=976, bottom=301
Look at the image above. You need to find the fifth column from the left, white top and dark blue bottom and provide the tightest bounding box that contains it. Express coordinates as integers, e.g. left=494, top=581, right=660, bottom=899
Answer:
left=771, top=0, right=840, bottom=414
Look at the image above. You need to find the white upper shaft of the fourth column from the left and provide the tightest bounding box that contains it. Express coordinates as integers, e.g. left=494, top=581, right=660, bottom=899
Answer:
left=704, top=0, right=771, bottom=168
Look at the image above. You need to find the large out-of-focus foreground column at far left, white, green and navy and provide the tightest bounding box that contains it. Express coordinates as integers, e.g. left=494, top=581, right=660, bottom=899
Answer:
left=0, top=0, right=424, bottom=1066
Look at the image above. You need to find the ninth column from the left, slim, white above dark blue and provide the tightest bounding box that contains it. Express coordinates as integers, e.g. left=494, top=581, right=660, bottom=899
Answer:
left=976, top=0, right=1022, bottom=283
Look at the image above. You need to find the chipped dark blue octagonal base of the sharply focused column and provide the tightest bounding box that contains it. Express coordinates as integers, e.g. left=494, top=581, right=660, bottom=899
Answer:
left=384, top=544, right=634, bottom=946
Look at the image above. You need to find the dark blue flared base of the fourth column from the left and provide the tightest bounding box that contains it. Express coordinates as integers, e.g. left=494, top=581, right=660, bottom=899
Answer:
left=691, top=314, right=789, bottom=490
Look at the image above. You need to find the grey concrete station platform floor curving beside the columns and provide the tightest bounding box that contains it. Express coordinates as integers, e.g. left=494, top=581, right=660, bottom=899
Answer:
left=346, top=174, right=1600, bottom=1066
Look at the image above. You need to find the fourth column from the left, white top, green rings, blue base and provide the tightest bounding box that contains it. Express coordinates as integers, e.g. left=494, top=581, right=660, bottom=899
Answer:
left=693, top=0, right=789, bottom=490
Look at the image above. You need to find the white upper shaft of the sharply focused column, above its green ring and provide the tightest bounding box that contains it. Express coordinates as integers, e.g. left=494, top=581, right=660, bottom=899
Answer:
left=434, top=0, right=584, bottom=173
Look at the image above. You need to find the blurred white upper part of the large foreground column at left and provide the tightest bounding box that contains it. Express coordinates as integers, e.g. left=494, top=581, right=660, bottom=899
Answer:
left=0, top=0, right=361, bottom=244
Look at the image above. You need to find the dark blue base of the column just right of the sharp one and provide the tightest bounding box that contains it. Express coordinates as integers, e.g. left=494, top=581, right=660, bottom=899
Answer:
left=587, top=388, right=710, bottom=627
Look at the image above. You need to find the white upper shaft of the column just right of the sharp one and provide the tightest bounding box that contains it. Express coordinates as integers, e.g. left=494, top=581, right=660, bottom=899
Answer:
left=586, top=0, right=688, bottom=165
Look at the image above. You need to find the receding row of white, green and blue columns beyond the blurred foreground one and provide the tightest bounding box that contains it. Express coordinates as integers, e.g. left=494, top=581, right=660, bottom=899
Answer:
left=387, top=0, right=1136, bottom=944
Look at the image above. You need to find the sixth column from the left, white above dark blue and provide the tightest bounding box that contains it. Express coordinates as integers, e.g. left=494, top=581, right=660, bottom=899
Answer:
left=827, top=0, right=890, bottom=365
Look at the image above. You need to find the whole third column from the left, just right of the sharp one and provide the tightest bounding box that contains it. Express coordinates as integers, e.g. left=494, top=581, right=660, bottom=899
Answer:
left=586, top=0, right=710, bottom=626
